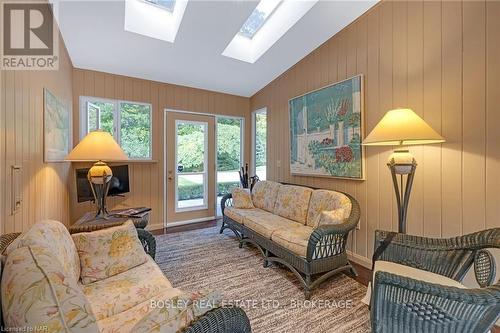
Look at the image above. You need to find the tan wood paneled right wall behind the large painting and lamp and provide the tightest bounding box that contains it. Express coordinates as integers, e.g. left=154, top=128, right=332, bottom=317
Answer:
left=251, top=0, right=500, bottom=262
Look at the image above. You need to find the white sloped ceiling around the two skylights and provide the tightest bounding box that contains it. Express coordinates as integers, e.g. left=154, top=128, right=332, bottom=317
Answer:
left=54, top=0, right=377, bottom=97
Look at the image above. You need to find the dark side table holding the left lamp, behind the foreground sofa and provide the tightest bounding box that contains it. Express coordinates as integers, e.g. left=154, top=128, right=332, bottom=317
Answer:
left=68, top=209, right=156, bottom=259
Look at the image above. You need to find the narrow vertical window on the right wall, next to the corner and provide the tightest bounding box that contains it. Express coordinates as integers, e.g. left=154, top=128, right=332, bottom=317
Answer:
left=252, top=108, right=267, bottom=180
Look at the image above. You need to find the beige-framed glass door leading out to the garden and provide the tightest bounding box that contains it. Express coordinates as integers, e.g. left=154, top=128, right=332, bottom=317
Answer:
left=165, top=112, right=216, bottom=223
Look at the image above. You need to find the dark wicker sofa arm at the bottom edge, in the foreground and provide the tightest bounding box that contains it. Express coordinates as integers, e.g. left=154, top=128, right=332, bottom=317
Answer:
left=184, top=307, right=252, bottom=333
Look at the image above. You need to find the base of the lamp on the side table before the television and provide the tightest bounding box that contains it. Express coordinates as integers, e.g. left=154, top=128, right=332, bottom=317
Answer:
left=87, top=161, right=113, bottom=219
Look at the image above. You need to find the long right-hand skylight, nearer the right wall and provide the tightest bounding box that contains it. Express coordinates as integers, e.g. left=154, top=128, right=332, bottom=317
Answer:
left=222, top=0, right=318, bottom=64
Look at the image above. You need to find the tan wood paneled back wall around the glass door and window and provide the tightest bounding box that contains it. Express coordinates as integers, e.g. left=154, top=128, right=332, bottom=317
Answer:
left=70, top=69, right=251, bottom=229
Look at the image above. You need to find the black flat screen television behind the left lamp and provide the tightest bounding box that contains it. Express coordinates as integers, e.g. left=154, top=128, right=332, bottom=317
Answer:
left=76, top=165, right=130, bottom=202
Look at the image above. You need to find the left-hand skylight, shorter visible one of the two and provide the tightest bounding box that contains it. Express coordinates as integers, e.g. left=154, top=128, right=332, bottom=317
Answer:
left=125, top=0, right=187, bottom=43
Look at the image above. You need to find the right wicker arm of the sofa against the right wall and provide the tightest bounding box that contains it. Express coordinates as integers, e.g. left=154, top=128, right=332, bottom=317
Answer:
left=306, top=193, right=361, bottom=261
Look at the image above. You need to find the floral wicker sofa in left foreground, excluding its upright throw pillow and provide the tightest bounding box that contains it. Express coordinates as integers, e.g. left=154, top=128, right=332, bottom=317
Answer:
left=0, top=220, right=251, bottom=333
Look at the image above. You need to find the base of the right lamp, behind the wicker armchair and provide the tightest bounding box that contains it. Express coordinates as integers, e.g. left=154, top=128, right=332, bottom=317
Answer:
left=387, top=149, right=417, bottom=233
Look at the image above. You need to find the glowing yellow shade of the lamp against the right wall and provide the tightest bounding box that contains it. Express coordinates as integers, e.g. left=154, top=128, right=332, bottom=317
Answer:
left=363, top=109, right=445, bottom=146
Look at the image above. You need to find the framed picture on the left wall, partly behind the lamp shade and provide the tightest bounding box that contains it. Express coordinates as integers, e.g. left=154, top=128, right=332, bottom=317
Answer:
left=43, top=88, right=72, bottom=163
